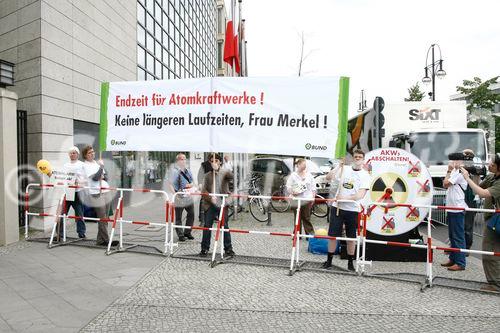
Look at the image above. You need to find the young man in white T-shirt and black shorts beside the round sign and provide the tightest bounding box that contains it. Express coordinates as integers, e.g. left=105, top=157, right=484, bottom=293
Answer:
left=322, top=149, right=370, bottom=271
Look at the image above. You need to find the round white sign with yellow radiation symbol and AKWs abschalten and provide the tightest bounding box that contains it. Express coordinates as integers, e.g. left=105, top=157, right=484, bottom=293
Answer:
left=362, top=148, right=433, bottom=235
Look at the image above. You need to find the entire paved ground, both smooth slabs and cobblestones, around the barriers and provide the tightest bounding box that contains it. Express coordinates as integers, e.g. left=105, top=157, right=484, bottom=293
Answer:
left=0, top=193, right=500, bottom=332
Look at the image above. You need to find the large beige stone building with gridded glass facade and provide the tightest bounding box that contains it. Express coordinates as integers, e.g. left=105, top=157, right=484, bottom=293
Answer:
left=0, top=0, right=223, bottom=228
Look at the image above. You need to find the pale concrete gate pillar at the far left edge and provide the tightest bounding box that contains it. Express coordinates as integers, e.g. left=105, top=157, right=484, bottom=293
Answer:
left=0, top=88, right=19, bottom=246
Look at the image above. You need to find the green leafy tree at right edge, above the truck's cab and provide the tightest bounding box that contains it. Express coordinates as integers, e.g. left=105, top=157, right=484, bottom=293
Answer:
left=457, top=76, right=500, bottom=112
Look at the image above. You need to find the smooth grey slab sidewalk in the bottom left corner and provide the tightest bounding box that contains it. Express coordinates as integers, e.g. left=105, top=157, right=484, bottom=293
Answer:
left=0, top=231, right=162, bottom=332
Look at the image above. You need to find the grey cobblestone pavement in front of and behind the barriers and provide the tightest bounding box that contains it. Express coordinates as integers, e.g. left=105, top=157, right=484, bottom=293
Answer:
left=82, top=200, right=500, bottom=332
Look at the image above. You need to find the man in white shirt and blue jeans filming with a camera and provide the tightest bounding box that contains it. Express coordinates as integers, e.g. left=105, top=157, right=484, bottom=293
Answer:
left=441, top=161, right=468, bottom=271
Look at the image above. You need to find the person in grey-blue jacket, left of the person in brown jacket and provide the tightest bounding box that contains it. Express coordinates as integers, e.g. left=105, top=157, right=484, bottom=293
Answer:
left=169, top=153, right=194, bottom=242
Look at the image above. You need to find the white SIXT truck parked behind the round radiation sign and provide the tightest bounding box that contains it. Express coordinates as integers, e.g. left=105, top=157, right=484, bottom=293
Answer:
left=348, top=101, right=488, bottom=187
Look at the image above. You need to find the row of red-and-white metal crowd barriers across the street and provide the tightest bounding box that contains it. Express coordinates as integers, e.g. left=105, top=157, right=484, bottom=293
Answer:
left=25, top=184, right=500, bottom=290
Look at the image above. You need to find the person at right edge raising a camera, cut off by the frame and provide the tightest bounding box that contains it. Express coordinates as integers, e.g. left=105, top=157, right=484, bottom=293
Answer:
left=460, top=153, right=500, bottom=291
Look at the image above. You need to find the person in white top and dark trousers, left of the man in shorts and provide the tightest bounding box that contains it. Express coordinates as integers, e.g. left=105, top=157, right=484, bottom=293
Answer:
left=286, top=158, right=316, bottom=235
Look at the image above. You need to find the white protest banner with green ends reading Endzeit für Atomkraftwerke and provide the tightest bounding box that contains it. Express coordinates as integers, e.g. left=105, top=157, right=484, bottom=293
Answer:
left=100, top=77, right=349, bottom=158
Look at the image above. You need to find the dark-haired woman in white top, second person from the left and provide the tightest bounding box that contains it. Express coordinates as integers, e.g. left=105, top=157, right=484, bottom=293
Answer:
left=82, top=145, right=111, bottom=245
